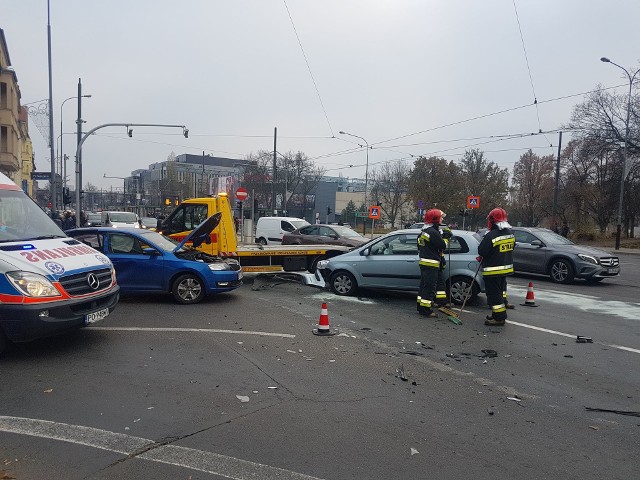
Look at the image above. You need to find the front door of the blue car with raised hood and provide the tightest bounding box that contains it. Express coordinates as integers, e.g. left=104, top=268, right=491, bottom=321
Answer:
left=106, top=232, right=164, bottom=292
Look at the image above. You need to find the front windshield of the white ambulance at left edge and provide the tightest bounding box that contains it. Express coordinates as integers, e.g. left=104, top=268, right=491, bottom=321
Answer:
left=0, top=189, right=66, bottom=243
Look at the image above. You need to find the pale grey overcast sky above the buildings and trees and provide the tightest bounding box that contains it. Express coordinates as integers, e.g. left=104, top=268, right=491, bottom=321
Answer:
left=0, top=0, right=640, bottom=188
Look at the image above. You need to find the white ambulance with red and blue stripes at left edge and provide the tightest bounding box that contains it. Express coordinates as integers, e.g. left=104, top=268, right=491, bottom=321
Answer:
left=0, top=173, right=120, bottom=352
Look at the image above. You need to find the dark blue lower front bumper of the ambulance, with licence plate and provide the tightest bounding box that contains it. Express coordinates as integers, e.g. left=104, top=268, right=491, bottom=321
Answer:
left=0, top=285, right=120, bottom=342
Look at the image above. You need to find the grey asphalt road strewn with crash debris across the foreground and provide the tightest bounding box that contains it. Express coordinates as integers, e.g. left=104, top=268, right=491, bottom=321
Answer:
left=0, top=255, right=640, bottom=480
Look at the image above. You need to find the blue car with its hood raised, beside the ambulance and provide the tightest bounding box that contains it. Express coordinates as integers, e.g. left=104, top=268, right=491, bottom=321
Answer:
left=66, top=213, right=242, bottom=304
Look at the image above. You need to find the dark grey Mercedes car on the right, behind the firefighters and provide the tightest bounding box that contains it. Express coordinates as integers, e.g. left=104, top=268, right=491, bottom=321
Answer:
left=511, top=227, right=620, bottom=283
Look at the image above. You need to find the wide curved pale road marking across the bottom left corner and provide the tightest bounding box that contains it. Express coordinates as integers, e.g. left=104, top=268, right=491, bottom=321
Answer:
left=0, top=416, right=320, bottom=480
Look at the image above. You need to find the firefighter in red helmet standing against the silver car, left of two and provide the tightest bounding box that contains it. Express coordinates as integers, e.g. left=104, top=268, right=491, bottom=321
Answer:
left=417, top=208, right=447, bottom=318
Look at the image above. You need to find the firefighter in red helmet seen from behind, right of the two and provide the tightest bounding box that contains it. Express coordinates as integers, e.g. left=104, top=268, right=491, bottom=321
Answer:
left=478, top=208, right=516, bottom=326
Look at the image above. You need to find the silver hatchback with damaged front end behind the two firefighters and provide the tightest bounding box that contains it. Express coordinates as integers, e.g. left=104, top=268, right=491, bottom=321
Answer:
left=315, top=229, right=484, bottom=304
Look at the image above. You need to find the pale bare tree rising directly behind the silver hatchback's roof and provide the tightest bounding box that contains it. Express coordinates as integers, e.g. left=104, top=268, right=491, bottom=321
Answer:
left=371, top=161, right=413, bottom=227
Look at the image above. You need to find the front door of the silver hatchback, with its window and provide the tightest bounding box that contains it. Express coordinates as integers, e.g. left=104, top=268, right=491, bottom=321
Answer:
left=350, top=233, right=420, bottom=291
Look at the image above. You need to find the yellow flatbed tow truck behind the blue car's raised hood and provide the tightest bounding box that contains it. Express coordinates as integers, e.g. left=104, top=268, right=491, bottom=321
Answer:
left=158, top=194, right=351, bottom=272
